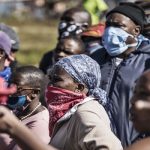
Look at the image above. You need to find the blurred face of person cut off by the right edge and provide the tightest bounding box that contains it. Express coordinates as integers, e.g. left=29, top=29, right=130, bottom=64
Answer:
left=131, top=73, right=150, bottom=132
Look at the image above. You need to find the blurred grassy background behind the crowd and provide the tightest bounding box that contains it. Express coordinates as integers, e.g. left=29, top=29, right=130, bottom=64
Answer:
left=0, top=0, right=134, bottom=65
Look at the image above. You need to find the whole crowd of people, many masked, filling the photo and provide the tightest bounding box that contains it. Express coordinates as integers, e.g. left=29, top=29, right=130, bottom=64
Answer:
left=0, top=1, right=150, bottom=150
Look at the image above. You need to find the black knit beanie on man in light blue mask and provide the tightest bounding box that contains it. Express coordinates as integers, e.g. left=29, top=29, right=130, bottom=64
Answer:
left=106, top=2, right=145, bottom=30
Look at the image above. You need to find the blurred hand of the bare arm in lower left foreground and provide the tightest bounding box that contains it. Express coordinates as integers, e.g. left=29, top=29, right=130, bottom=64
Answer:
left=0, top=106, right=19, bottom=135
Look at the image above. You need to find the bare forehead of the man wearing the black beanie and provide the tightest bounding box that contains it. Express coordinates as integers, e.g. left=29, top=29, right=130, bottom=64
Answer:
left=107, top=13, right=135, bottom=25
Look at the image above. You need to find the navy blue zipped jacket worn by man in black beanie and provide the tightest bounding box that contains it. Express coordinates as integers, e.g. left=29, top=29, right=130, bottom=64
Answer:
left=91, top=42, right=150, bottom=146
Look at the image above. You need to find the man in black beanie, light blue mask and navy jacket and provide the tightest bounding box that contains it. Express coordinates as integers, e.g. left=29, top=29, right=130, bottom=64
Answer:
left=92, top=3, right=150, bottom=147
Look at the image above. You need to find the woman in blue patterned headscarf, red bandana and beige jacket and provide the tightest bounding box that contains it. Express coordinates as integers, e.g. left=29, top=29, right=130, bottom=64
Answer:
left=46, top=54, right=122, bottom=150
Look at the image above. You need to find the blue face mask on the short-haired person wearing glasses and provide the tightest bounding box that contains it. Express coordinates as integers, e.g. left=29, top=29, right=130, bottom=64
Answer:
left=7, top=95, right=27, bottom=109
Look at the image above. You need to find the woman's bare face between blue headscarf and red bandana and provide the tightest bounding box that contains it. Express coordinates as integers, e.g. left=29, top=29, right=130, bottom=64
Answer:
left=49, top=66, right=78, bottom=92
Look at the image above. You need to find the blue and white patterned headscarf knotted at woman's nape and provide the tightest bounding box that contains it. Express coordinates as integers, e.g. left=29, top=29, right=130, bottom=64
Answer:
left=54, top=54, right=107, bottom=106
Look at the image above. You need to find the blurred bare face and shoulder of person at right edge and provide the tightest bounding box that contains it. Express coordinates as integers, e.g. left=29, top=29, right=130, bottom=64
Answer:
left=126, top=71, right=150, bottom=150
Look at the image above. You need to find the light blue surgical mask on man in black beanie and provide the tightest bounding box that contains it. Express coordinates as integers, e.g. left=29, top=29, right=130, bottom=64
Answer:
left=102, top=27, right=138, bottom=56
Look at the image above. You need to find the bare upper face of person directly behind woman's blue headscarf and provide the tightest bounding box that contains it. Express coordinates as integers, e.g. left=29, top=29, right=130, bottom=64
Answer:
left=54, top=39, right=83, bottom=62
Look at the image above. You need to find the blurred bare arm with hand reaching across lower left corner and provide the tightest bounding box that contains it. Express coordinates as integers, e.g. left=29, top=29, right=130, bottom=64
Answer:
left=0, top=106, right=56, bottom=150
